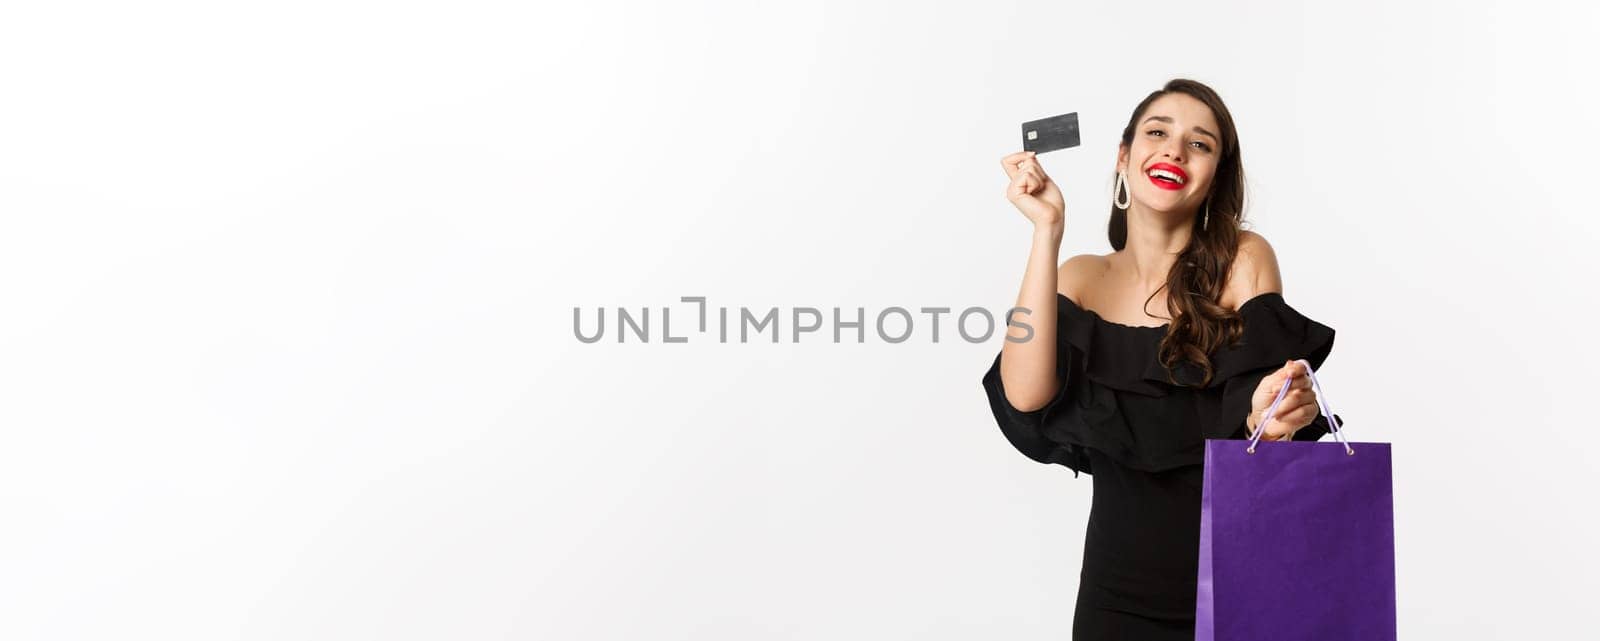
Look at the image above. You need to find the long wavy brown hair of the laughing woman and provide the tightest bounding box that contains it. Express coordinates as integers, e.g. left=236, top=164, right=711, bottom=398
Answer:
left=1106, top=78, right=1245, bottom=387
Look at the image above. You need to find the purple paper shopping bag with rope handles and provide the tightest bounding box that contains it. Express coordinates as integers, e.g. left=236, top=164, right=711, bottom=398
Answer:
left=1195, top=360, right=1395, bottom=641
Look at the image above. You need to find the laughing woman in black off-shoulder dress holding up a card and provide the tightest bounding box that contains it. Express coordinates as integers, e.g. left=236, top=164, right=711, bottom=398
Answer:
left=984, top=80, right=1342, bottom=641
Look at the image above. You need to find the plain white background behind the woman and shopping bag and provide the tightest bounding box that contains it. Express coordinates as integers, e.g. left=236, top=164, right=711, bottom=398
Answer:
left=0, top=2, right=1600, bottom=639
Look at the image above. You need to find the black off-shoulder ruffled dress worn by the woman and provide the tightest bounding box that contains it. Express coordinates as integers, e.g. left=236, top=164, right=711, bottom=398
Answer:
left=982, top=293, right=1344, bottom=641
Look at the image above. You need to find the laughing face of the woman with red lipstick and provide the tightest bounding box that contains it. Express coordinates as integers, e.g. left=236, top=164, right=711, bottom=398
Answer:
left=1117, top=93, right=1222, bottom=213
